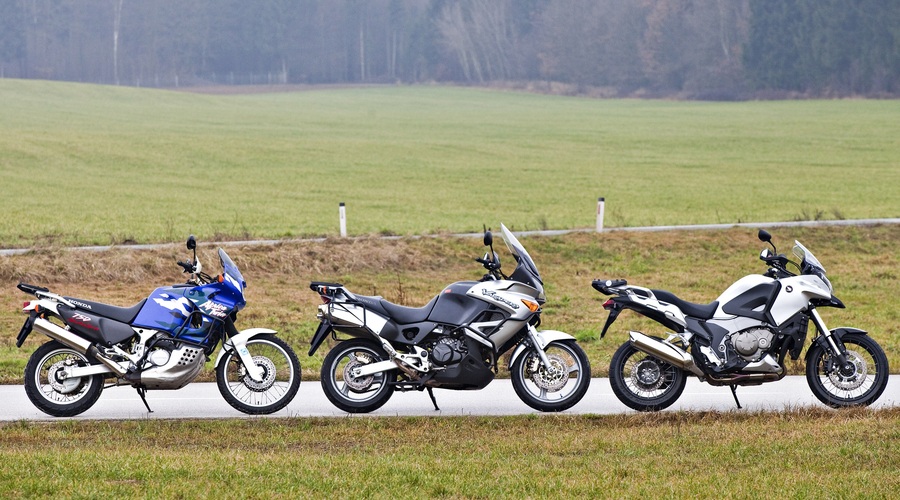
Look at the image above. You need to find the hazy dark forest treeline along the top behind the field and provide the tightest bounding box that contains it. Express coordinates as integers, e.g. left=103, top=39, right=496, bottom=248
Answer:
left=0, top=0, right=900, bottom=99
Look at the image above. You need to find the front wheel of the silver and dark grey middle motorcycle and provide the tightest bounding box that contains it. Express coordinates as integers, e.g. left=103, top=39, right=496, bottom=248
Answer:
left=510, top=340, right=591, bottom=411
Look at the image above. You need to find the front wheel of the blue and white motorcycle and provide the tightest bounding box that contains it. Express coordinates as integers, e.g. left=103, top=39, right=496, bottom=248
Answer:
left=216, top=335, right=300, bottom=415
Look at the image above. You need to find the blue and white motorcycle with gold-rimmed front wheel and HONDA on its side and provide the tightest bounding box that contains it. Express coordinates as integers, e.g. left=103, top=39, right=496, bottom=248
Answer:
left=16, top=236, right=300, bottom=417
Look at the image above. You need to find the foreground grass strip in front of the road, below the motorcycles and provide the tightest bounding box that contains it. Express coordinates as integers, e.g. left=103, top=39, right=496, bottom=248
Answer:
left=0, top=408, right=900, bottom=498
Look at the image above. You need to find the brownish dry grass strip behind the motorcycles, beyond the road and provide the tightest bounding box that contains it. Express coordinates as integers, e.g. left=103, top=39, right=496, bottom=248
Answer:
left=0, top=225, right=900, bottom=383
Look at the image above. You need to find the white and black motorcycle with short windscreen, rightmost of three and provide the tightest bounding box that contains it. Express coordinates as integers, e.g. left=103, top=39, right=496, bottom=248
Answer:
left=593, top=230, right=888, bottom=411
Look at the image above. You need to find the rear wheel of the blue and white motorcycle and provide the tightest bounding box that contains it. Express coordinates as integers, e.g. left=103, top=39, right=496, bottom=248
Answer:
left=25, top=340, right=103, bottom=417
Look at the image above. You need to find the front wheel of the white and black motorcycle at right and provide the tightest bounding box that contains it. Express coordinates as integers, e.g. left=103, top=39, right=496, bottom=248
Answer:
left=806, top=333, right=888, bottom=408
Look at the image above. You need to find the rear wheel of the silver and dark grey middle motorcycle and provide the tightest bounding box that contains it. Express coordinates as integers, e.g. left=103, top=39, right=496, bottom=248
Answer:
left=322, top=339, right=397, bottom=413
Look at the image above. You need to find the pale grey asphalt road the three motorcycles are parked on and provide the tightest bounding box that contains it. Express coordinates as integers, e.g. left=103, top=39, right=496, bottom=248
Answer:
left=0, top=375, right=900, bottom=421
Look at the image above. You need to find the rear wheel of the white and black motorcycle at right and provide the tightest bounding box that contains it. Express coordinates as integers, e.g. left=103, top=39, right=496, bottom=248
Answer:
left=609, top=342, right=687, bottom=411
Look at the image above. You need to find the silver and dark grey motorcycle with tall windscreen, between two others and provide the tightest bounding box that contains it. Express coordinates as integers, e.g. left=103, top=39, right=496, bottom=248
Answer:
left=309, top=224, right=591, bottom=413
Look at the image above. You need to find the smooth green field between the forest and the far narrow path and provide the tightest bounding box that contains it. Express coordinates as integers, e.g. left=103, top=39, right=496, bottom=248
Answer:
left=0, top=80, right=900, bottom=248
